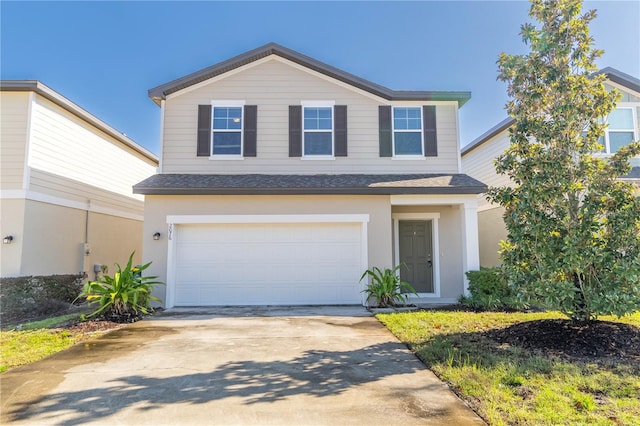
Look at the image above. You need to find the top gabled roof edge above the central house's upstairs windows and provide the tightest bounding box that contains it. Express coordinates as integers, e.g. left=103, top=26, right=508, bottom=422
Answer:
left=149, top=43, right=471, bottom=107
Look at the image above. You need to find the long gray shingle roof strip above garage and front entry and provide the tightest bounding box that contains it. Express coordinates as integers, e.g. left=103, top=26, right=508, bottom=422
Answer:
left=133, top=174, right=486, bottom=195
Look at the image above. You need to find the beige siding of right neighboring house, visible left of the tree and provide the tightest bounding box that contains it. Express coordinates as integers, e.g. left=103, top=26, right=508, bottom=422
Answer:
left=462, top=130, right=509, bottom=209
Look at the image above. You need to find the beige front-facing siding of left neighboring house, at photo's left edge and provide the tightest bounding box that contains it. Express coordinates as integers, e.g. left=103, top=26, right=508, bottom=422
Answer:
left=0, top=92, right=30, bottom=190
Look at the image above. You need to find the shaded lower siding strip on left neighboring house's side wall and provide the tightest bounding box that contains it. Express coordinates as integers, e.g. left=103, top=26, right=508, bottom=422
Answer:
left=30, top=169, right=144, bottom=218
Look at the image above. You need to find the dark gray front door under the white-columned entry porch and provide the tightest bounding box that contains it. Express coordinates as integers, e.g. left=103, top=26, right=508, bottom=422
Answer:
left=398, top=220, right=434, bottom=293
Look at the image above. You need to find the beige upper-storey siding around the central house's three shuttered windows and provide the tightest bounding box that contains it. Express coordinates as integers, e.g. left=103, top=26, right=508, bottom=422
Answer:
left=162, top=59, right=458, bottom=174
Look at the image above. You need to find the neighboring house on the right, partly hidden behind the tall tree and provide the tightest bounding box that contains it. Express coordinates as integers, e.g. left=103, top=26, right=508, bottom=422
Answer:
left=462, top=68, right=640, bottom=267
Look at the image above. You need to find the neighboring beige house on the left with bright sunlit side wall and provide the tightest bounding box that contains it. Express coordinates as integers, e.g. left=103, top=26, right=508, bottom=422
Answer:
left=0, top=80, right=158, bottom=279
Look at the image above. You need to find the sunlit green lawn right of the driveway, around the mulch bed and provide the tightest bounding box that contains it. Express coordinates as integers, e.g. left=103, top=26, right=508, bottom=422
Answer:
left=377, top=311, right=640, bottom=425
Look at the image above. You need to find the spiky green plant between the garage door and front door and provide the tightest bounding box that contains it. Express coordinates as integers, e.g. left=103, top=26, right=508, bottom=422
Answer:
left=360, top=265, right=416, bottom=308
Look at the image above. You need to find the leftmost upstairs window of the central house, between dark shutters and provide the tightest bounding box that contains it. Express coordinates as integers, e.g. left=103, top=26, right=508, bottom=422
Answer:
left=211, top=105, right=243, bottom=156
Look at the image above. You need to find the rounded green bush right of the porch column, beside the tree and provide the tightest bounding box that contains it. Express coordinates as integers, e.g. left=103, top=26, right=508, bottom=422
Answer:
left=460, top=268, right=526, bottom=310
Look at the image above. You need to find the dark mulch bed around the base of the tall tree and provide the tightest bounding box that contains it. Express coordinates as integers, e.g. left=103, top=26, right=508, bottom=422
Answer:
left=483, top=319, right=640, bottom=361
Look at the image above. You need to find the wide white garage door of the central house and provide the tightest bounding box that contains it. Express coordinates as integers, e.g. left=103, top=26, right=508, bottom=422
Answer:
left=169, top=223, right=363, bottom=306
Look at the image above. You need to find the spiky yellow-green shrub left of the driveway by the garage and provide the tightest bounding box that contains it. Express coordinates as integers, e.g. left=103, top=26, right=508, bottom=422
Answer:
left=78, top=252, right=164, bottom=322
